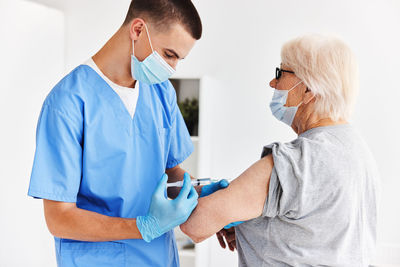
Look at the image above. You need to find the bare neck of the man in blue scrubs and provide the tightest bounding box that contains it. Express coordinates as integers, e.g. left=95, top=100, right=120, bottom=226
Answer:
left=92, top=27, right=136, bottom=88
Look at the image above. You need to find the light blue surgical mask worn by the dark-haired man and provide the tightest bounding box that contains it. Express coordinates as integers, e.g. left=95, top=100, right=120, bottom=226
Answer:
left=131, top=24, right=175, bottom=84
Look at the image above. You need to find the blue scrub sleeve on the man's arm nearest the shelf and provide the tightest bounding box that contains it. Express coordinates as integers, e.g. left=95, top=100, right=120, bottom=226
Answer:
left=166, top=85, right=194, bottom=169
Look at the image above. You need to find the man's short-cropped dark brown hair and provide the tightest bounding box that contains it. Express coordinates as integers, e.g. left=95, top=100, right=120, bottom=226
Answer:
left=124, top=0, right=202, bottom=40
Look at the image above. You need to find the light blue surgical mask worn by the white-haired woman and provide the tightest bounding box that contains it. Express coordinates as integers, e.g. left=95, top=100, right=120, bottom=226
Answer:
left=269, top=81, right=303, bottom=126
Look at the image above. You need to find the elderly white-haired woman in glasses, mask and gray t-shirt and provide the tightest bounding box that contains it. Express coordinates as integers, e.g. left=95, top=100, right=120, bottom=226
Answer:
left=181, top=35, right=379, bottom=267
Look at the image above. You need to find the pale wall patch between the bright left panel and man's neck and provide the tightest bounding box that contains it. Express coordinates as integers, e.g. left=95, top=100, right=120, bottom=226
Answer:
left=30, top=0, right=130, bottom=72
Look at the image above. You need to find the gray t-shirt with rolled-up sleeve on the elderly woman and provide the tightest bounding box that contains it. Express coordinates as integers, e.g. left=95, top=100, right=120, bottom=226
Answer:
left=236, top=124, right=379, bottom=267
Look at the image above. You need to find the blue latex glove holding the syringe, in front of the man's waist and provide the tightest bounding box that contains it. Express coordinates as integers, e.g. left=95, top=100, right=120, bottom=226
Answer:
left=136, top=173, right=198, bottom=242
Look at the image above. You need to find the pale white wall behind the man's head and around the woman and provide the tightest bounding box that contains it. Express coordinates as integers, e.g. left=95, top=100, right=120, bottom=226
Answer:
left=8, top=0, right=400, bottom=266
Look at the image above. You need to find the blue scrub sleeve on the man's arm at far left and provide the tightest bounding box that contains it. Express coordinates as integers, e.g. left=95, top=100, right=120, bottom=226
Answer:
left=28, top=98, right=82, bottom=202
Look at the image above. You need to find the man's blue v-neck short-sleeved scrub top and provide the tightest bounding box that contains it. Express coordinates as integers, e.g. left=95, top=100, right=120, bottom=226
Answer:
left=28, top=65, right=193, bottom=267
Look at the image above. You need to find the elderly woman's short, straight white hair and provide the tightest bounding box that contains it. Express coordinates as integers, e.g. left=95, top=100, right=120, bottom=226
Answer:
left=281, top=34, right=359, bottom=120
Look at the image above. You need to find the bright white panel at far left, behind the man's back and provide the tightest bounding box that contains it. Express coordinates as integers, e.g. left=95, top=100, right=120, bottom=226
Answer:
left=0, top=0, right=64, bottom=267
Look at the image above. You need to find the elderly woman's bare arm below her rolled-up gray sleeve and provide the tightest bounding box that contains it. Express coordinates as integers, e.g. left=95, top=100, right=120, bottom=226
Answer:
left=181, top=155, right=274, bottom=242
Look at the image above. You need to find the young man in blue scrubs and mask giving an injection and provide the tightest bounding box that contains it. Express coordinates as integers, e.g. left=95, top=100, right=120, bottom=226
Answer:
left=28, top=0, right=226, bottom=267
